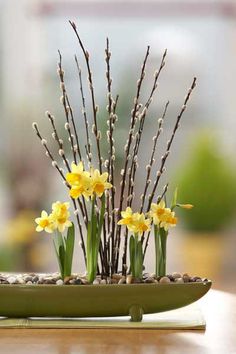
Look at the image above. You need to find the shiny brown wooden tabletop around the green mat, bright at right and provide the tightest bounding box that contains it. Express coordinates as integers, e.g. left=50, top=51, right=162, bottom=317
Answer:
left=0, top=290, right=236, bottom=354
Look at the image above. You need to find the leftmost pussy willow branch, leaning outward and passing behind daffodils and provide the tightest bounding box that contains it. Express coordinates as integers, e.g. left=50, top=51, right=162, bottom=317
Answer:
left=33, top=123, right=86, bottom=264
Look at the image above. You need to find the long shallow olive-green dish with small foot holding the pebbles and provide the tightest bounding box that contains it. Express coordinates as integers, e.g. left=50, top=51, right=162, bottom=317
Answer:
left=0, top=281, right=211, bottom=321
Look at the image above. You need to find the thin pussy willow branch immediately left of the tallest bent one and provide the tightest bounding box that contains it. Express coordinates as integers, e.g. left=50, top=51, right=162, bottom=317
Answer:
left=75, top=55, right=92, bottom=167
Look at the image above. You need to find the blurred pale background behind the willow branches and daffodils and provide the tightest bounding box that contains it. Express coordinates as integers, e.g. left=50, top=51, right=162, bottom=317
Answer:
left=0, top=0, right=236, bottom=291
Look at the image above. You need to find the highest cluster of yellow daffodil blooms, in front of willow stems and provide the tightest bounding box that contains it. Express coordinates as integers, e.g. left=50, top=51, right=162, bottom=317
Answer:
left=66, top=162, right=112, bottom=200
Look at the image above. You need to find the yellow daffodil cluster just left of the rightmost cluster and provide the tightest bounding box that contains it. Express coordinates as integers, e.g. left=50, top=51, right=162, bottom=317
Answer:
left=118, top=207, right=151, bottom=235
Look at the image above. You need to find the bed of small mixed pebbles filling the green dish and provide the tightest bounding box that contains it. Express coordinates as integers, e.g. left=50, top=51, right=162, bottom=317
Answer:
left=0, top=272, right=208, bottom=285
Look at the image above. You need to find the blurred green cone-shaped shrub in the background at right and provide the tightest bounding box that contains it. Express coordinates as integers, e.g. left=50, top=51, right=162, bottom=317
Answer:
left=177, top=133, right=236, bottom=231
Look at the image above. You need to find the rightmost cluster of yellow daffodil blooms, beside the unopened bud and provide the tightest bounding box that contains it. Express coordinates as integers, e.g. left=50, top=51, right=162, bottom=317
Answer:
left=149, top=200, right=178, bottom=231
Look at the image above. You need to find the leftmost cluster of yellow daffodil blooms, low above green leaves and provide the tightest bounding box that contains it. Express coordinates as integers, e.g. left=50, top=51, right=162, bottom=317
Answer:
left=35, top=202, right=72, bottom=233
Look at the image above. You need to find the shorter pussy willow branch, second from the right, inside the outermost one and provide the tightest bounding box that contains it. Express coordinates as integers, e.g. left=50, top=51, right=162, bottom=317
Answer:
left=140, top=101, right=169, bottom=213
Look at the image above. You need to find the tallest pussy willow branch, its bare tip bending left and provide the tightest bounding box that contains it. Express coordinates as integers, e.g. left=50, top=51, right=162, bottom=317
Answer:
left=69, top=21, right=102, bottom=173
